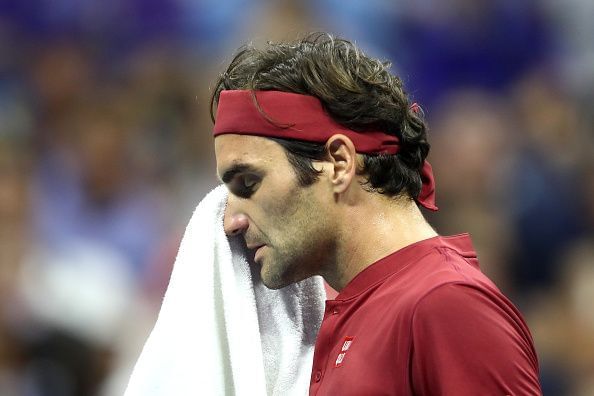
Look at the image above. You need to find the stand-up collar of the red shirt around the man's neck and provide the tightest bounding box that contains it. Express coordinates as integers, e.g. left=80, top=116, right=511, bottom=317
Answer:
left=336, top=233, right=478, bottom=300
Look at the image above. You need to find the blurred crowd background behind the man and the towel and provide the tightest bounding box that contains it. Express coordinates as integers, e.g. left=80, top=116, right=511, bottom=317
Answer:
left=0, top=0, right=594, bottom=396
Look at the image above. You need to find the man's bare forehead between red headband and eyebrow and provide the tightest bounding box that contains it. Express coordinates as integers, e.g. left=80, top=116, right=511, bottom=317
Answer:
left=215, top=134, right=288, bottom=175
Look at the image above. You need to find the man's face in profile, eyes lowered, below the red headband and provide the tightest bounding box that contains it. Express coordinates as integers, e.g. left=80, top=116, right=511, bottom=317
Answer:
left=215, top=134, right=335, bottom=289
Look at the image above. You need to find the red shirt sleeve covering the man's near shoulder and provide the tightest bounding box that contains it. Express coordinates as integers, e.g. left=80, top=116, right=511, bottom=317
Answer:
left=411, top=283, right=539, bottom=394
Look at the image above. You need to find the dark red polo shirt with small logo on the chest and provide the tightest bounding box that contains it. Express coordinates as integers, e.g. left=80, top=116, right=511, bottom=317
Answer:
left=309, top=234, right=541, bottom=396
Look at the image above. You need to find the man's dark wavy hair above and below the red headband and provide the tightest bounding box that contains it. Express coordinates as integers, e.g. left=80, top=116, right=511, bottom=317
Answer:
left=210, top=33, right=430, bottom=199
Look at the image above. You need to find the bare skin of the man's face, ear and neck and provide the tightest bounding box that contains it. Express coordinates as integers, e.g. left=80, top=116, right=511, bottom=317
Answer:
left=215, top=134, right=437, bottom=291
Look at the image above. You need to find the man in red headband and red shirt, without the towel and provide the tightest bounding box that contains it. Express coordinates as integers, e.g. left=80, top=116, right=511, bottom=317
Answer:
left=211, top=34, right=540, bottom=395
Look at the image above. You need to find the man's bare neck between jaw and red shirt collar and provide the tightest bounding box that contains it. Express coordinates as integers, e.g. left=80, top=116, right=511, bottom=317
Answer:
left=322, top=193, right=437, bottom=291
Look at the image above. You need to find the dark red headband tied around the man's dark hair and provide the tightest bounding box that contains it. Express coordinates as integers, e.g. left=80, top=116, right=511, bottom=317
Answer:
left=214, top=90, right=437, bottom=210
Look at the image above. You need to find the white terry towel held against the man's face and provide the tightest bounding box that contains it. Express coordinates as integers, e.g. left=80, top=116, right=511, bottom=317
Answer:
left=125, top=186, right=326, bottom=396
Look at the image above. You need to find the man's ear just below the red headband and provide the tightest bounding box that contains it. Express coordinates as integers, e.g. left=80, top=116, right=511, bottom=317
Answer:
left=326, top=134, right=357, bottom=193
